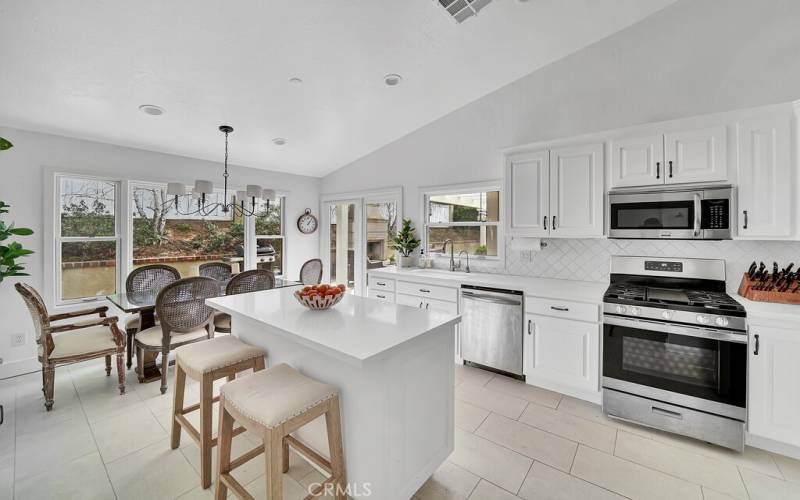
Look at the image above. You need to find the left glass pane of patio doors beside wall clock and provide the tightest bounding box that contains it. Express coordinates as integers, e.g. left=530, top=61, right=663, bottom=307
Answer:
left=328, top=203, right=356, bottom=290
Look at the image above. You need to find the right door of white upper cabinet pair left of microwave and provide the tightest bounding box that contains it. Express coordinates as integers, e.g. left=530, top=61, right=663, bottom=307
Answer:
left=550, top=143, right=604, bottom=237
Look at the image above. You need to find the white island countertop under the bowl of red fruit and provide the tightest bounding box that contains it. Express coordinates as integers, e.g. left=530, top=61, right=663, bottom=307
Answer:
left=206, top=288, right=461, bottom=365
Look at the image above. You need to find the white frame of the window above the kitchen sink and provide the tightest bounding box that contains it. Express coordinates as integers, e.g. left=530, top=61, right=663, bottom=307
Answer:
left=420, top=179, right=506, bottom=265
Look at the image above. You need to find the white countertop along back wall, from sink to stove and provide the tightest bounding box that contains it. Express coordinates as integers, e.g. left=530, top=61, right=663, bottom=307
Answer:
left=368, top=267, right=608, bottom=304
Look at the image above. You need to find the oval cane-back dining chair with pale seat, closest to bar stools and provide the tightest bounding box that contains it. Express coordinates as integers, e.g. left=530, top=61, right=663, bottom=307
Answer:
left=134, top=276, right=220, bottom=394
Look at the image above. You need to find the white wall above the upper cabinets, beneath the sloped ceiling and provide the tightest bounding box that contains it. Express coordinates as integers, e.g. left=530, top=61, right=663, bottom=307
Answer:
left=322, top=0, right=800, bottom=223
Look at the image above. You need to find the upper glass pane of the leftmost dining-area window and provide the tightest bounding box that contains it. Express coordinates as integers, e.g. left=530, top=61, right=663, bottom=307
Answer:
left=59, top=177, right=117, bottom=238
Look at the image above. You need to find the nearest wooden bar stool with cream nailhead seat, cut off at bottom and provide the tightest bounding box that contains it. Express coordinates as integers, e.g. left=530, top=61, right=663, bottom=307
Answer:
left=215, top=364, right=347, bottom=500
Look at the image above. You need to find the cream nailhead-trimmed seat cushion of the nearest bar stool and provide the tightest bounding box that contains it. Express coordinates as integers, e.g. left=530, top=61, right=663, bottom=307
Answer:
left=220, top=364, right=336, bottom=429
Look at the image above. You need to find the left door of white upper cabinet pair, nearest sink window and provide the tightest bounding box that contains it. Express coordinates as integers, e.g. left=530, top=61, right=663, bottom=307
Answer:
left=505, top=150, right=550, bottom=236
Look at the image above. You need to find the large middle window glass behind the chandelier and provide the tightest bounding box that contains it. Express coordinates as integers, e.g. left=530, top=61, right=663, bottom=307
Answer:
left=131, top=183, right=244, bottom=277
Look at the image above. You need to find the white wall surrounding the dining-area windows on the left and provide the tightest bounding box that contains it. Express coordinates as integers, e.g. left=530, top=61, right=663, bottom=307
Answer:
left=0, top=127, right=320, bottom=375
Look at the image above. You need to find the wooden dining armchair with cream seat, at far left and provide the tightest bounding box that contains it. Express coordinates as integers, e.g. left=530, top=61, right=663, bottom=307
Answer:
left=14, top=283, right=125, bottom=411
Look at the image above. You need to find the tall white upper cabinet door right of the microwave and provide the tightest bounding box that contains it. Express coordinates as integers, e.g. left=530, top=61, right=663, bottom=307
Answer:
left=738, top=116, right=794, bottom=239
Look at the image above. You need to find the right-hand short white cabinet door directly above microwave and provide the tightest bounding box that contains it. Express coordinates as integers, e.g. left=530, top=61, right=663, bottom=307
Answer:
left=664, top=126, right=728, bottom=184
